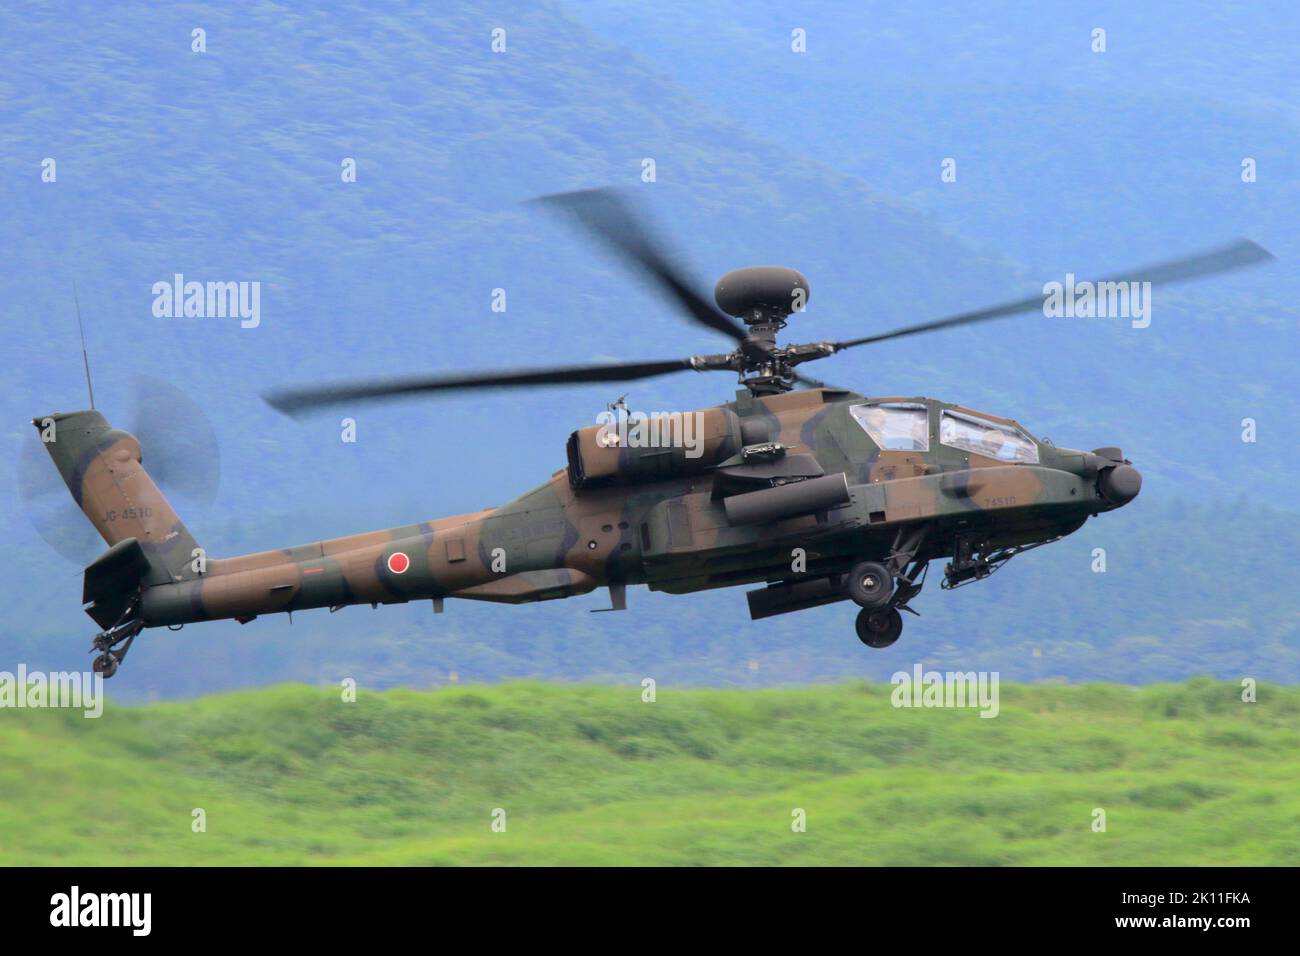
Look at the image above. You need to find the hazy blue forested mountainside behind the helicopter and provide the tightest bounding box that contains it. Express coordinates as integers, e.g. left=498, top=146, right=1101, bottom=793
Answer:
left=0, top=0, right=1300, bottom=697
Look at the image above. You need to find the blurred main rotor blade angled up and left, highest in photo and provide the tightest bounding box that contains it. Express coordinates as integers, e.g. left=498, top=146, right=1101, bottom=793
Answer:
left=529, top=189, right=748, bottom=342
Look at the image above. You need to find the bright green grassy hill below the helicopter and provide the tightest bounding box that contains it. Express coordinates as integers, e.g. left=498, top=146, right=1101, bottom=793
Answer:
left=0, top=680, right=1300, bottom=865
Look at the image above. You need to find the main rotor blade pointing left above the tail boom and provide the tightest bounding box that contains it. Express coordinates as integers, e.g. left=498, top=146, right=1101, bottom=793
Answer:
left=264, top=359, right=694, bottom=415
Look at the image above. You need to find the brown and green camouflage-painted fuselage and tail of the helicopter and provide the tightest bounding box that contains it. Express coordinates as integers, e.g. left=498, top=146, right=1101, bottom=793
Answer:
left=33, top=389, right=1136, bottom=627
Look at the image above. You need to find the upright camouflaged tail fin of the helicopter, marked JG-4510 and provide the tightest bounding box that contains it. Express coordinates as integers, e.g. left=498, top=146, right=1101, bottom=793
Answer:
left=31, top=411, right=198, bottom=584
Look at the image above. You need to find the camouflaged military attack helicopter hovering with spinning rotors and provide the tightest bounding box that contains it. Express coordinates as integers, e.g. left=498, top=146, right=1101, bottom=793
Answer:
left=33, top=189, right=1273, bottom=678
